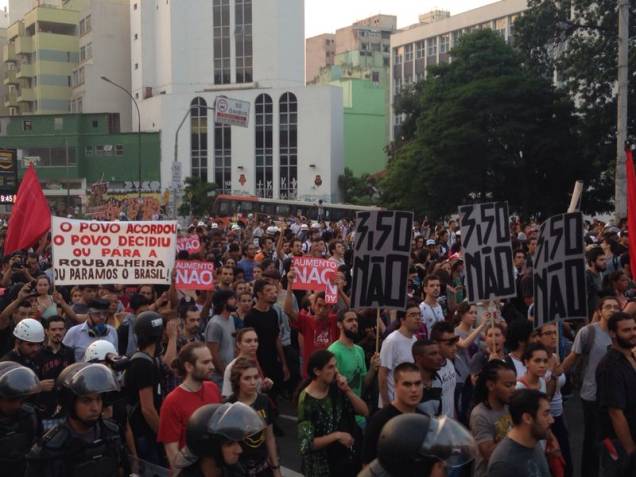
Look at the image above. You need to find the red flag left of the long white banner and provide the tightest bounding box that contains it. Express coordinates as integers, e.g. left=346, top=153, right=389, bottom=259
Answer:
left=4, top=164, right=51, bottom=256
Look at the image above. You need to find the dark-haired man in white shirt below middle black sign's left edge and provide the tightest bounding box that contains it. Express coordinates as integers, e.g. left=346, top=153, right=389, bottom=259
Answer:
left=431, top=321, right=459, bottom=418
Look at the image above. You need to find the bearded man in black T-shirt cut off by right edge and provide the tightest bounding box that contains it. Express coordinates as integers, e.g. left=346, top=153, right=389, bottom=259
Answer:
left=596, top=312, right=636, bottom=477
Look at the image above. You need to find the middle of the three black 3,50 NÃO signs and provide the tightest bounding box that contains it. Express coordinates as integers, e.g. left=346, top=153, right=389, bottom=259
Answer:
left=459, top=202, right=516, bottom=303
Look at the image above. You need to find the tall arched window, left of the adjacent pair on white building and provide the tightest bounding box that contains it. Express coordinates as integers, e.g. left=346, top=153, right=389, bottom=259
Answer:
left=255, top=94, right=274, bottom=197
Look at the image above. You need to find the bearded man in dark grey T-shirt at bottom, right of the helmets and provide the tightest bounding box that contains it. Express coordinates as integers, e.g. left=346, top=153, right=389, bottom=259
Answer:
left=487, top=389, right=554, bottom=477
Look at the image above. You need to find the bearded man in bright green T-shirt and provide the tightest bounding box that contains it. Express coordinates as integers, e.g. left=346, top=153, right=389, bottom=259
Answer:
left=328, top=310, right=380, bottom=422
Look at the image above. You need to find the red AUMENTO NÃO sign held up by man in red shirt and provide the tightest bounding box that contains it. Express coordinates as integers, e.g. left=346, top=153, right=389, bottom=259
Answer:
left=292, top=257, right=338, bottom=304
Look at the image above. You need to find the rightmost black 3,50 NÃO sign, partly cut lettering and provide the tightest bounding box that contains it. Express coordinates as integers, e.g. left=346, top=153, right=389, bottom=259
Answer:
left=533, top=212, right=587, bottom=326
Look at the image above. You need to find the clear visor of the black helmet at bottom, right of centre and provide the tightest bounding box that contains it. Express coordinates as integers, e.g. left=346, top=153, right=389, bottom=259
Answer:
left=420, top=416, right=477, bottom=469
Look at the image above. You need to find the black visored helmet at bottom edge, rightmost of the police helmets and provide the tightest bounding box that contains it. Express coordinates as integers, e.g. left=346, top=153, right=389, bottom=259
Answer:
left=378, top=413, right=477, bottom=476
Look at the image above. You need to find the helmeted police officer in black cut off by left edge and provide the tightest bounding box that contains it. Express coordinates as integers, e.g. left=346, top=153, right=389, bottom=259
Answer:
left=0, top=361, right=41, bottom=477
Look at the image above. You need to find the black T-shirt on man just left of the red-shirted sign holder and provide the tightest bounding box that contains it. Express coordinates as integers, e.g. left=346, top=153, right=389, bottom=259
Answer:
left=243, top=308, right=282, bottom=382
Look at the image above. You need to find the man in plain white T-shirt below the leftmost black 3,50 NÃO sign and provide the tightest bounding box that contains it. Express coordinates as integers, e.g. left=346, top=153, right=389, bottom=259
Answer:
left=378, top=303, right=421, bottom=408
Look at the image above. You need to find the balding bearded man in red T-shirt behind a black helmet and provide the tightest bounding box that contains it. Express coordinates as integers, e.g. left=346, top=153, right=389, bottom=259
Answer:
left=157, top=342, right=221, bottom=468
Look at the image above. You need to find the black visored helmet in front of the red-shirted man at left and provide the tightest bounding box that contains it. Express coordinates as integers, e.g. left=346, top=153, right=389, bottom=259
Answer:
left=186, top=402, right=266, bottom=458
